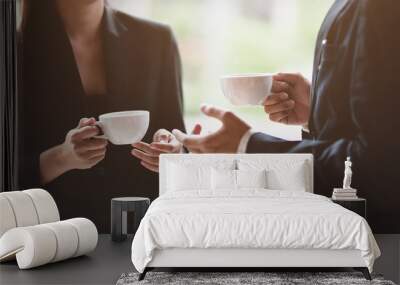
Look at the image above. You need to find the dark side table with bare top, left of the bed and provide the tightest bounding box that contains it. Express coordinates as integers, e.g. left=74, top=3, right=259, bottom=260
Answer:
left=111, top=197, right=150, bottom=241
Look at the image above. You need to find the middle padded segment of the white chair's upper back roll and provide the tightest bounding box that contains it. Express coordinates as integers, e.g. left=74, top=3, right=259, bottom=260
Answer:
left=1, top=191, right=39, bottom=227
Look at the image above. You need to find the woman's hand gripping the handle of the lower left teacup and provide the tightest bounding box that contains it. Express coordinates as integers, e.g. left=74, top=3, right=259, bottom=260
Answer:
left=62, top=118, right=108, bottom=170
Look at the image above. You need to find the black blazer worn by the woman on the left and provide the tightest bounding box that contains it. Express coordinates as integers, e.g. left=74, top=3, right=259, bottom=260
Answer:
left=19, top=5, right=184, bottom=232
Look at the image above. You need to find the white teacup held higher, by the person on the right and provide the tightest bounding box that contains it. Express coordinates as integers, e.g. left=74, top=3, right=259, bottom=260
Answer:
left=221, top=73, right=273, bottom=106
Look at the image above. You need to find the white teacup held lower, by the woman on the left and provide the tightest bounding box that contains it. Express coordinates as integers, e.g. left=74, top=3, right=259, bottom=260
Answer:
left=97, top=111, right=150, bottom=145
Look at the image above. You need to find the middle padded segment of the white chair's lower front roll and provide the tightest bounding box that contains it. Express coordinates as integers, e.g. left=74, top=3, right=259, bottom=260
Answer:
left=43, top=221, right=79, bottom=262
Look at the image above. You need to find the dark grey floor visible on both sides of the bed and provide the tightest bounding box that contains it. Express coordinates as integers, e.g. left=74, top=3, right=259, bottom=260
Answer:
left=0, top=235, right=400, bottom=285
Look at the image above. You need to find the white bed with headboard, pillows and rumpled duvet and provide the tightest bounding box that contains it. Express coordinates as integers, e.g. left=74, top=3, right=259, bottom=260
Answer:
left=132, top=154, right=380, bottom=280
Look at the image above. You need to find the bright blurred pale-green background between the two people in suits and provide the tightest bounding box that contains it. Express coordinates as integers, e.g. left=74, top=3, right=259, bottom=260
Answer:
left=108, top=0, right=333, bottom=139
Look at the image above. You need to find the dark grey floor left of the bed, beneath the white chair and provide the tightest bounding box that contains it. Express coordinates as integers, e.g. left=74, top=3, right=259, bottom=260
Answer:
left=0, top=235, right=134, bottom=285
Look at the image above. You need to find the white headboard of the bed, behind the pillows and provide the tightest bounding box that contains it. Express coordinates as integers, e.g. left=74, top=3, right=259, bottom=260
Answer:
left=159, top=154, right=314, bottom=195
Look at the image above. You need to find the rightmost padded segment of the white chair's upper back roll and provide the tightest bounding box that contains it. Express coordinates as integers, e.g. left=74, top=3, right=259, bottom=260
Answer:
left=22, top=189, right=60, bottom=224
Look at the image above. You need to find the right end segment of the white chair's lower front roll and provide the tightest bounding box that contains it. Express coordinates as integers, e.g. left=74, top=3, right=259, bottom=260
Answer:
left=64, top=218, right=98, bottom=257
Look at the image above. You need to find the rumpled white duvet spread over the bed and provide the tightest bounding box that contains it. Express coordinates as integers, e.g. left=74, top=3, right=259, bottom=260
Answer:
left=132, top=189, right=380, bottom=272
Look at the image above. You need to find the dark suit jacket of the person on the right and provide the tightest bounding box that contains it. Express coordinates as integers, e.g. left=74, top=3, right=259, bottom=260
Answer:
left=247, top=0, right=400, bottom=233
